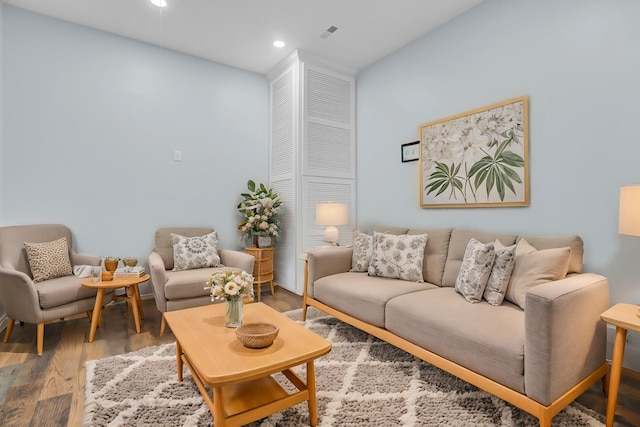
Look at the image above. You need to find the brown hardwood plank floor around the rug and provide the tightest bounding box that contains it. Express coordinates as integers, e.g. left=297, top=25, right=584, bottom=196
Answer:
left=0, top=286, right=640, bottom=427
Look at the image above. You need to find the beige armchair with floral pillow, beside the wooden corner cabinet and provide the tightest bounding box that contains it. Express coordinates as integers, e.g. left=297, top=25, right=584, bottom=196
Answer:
left=149, top=227, right=255, bottom=334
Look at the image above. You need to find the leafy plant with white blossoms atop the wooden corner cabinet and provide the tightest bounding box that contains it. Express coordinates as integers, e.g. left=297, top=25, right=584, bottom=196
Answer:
left=238, top=180, right=282, bottom=239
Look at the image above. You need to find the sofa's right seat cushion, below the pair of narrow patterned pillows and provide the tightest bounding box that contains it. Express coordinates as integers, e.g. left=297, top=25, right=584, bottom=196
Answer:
left=385, top=288, right=524, bottom=393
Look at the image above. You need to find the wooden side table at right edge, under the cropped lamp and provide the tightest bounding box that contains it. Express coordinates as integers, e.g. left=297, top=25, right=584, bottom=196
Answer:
left=600, top=304, right=640, bottom=427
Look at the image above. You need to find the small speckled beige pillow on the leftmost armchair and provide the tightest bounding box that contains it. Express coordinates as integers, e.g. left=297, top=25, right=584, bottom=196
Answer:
left=24, top=237, right=73, bottom=283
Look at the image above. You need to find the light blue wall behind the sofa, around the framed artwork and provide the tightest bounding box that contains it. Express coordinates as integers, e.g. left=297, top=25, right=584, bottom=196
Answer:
left=357, top=0, right=640, bottom=369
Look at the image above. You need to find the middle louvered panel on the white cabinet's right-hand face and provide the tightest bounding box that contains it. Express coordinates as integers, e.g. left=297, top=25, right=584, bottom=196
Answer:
left=305, top=123, right=355, bottom=178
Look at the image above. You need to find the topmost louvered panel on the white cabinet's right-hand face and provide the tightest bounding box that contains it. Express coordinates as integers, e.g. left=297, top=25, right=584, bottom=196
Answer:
left=306, top=67, right=353, bottom=125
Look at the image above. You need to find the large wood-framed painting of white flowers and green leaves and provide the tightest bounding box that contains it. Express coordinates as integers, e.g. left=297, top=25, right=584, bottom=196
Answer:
left=418, top=96, right=529, bottom=208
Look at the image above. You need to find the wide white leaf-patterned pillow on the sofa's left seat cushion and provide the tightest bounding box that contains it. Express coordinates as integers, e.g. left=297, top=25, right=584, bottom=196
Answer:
left=367, top=233, right=427, bottom=282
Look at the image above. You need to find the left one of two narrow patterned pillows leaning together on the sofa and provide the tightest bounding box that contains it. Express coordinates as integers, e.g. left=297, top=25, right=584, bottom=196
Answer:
left=455, top=238, right=496, bottom=303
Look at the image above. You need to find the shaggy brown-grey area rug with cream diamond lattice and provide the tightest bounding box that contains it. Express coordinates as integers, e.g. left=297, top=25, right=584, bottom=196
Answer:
left=84, top=308, right=604, bottom=427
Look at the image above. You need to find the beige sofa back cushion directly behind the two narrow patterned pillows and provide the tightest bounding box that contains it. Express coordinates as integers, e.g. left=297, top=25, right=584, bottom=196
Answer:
left=442, top=228, right=516, bottom=287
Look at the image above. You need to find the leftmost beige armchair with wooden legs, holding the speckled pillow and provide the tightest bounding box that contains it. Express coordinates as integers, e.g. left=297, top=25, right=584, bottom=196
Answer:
left=0, top=224, right=107, bottom=355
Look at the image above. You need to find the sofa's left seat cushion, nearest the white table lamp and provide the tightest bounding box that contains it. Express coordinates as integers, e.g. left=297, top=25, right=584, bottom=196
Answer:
left=314, top=272, right=437, bottom=328
